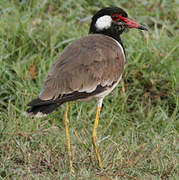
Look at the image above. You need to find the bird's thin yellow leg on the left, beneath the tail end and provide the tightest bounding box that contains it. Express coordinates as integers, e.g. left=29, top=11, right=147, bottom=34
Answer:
left=65, top=102, right=74, bottom=173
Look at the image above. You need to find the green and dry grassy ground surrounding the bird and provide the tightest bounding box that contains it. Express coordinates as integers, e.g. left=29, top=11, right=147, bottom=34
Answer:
left=0, top=0, right=179, bottom=180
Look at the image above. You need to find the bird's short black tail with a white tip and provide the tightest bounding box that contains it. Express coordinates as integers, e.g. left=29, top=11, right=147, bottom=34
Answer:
left=25, top=98, right=62, bottom=117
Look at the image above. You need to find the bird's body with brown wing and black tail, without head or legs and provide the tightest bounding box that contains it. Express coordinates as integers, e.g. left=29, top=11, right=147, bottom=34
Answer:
left=26, top=34, right=125, bottom=116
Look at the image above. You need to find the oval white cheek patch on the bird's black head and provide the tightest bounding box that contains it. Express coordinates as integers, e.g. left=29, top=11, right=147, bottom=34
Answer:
left=95, top=15, right=112, bottom=30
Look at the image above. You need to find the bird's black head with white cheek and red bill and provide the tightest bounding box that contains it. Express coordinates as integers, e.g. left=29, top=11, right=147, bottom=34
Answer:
left=89, top=7, right=147, bottom=41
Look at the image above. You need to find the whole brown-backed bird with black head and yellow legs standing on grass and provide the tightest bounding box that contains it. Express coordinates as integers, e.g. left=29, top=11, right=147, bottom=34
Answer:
left=25, top=7, right=148, bottom=172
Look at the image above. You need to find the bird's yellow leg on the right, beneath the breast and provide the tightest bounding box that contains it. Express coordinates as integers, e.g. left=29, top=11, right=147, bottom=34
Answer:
left=92, top=106, right=103, bottom=169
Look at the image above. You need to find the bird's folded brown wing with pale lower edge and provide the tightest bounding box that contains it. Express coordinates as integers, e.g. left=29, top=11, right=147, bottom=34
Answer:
left=39, top=34, right=125, bottom=100
